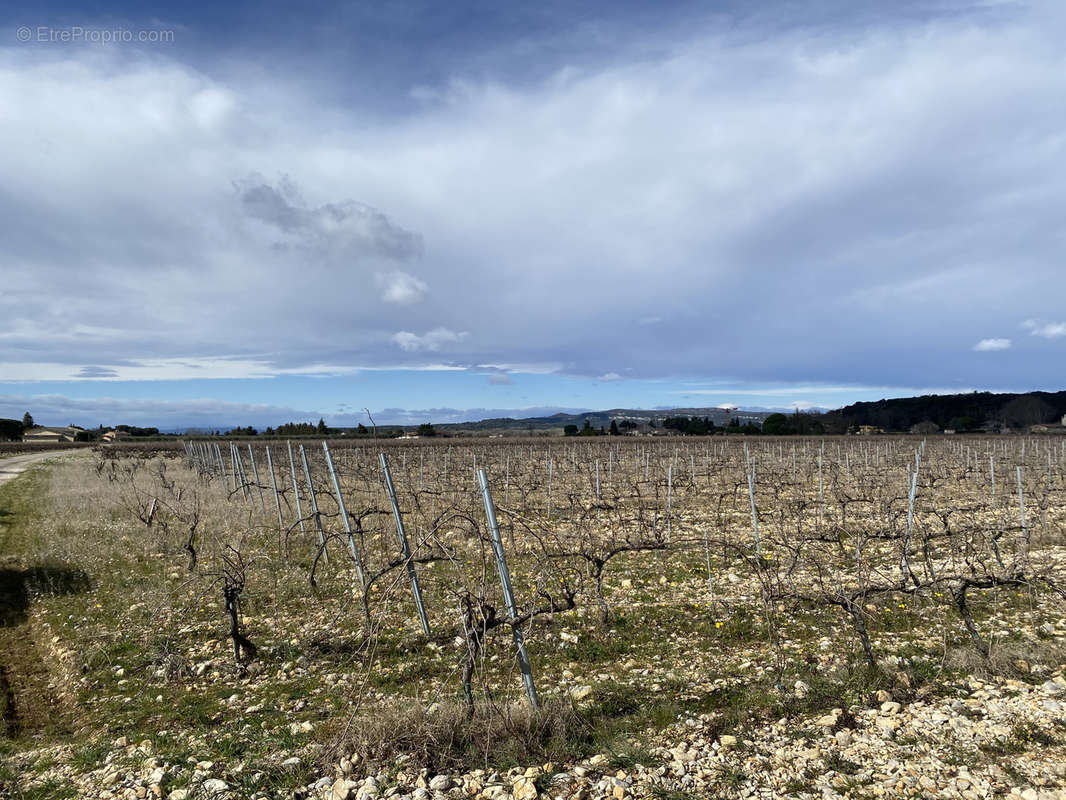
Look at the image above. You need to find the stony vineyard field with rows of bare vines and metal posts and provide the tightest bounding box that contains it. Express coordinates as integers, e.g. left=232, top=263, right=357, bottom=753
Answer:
left=0, top=436, right=1066, bottom=800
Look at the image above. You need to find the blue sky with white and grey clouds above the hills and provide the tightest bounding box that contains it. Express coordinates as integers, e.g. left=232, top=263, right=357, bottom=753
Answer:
left=0, top=0, right=1066, bottom=428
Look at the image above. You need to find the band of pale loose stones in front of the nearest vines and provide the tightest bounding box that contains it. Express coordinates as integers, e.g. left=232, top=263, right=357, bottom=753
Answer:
left=12, top=665, right=1066, bottom=800
